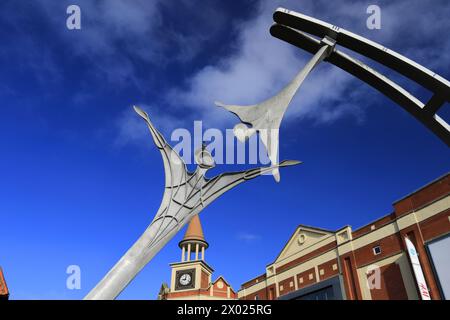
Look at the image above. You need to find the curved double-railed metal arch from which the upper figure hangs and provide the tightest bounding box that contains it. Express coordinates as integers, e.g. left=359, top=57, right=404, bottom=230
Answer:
left=270, top=8, right=450, bottom=146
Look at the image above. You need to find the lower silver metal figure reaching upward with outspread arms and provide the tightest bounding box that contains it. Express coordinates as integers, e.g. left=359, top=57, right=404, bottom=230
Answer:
left=85, top=107, right=300, bottom=300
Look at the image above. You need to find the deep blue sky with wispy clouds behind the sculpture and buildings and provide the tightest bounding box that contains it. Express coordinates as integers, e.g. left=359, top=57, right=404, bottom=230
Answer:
left=0, top=0, right=450, bottom=299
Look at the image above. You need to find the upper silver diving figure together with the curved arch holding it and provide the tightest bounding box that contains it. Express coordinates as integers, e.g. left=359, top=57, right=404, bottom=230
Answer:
left=216, top=8, right=450, bottom=175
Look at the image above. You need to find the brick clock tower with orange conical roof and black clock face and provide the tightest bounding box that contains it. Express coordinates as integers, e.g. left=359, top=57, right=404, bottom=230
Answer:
left=158, top=215, right=237, bottom=300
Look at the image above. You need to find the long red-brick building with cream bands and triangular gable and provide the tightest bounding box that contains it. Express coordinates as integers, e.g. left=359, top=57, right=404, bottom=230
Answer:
left=238, top=174, right=450, bottom=300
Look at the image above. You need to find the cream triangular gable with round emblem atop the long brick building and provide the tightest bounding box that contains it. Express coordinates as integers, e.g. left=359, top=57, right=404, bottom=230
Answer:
left=274, top=226, right=333, bottom=263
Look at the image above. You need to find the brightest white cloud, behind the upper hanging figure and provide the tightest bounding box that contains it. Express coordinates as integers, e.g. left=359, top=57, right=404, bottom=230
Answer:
left=169, top=3, right=352, bottom=124
